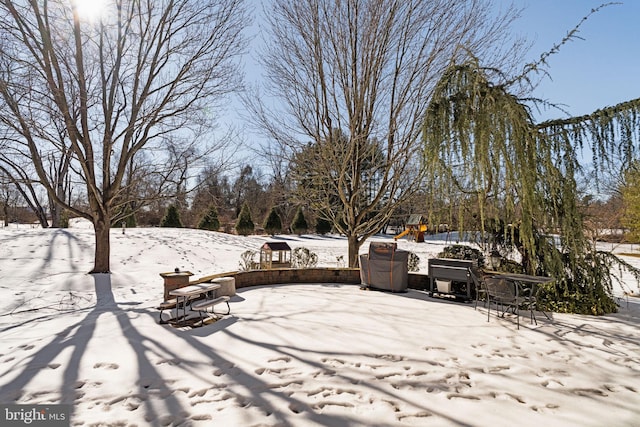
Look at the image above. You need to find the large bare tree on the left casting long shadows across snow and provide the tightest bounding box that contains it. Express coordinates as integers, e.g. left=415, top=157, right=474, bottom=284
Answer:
left=0, top=0, right=247, bottom=272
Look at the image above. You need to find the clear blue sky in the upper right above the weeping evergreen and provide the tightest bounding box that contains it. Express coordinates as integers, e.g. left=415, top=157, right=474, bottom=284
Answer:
left=514, top=0, right=640, bottom=119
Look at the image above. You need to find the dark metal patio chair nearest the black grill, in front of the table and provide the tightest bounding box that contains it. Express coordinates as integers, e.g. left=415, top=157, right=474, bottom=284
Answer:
left=484, top=277, right=538, bottom=329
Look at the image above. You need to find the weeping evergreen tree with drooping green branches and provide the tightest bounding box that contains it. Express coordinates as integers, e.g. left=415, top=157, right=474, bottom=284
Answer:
left=423, top=5, right=640, bottom=314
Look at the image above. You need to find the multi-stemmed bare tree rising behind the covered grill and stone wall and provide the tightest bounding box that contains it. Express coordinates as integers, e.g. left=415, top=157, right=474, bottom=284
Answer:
left=248, top=0, right=515, bottom=266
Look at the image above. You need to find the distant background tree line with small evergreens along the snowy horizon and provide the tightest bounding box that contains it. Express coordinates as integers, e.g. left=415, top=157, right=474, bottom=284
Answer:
left=0, top=152, right=640, bottom=243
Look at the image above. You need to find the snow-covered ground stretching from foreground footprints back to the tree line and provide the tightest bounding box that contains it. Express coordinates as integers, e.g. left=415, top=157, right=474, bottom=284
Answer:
left=0, top=224, right=640, bottom=427
